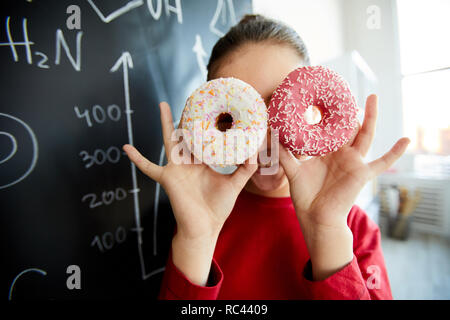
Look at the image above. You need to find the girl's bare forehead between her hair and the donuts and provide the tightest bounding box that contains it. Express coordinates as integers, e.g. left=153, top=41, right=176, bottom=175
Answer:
left=215, top=43, right=302, bottom=103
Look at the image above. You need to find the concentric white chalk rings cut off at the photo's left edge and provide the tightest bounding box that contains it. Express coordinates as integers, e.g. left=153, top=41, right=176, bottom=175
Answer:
left=0, top=112, right=38, bottom=190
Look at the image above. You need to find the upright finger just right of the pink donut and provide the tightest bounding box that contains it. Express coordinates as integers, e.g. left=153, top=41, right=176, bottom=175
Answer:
left=352, top=94, right=378, bottom=156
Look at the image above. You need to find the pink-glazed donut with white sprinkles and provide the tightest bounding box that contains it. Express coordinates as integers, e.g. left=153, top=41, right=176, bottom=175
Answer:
left=268, top=66, right=358, bottom=156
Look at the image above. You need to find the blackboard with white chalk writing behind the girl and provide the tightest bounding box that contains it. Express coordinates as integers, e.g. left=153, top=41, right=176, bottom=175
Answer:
left=0, top=0, right=252, bottom=301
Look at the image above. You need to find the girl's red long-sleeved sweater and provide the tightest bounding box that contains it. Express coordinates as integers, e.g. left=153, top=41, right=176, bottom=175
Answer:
left=159, top=191, right=392, bottom=300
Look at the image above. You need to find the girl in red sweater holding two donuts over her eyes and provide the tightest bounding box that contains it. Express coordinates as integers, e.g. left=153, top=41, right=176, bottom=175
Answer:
left=123, top=15, right=409, bottom=299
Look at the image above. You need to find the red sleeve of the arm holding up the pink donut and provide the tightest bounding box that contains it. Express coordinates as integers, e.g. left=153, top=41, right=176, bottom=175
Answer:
left=303, top=206, right=392, bottom=300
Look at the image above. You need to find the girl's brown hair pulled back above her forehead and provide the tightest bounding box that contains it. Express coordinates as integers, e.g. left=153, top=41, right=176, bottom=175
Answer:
left=207, top=14, right=310, bottom=80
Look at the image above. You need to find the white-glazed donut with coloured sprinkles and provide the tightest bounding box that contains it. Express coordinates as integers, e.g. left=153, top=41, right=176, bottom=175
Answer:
left=181, top=78, right=267, bottom=167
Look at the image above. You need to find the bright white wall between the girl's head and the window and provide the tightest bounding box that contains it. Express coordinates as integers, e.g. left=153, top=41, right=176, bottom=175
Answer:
left=253, top=0, right=403, bottom=167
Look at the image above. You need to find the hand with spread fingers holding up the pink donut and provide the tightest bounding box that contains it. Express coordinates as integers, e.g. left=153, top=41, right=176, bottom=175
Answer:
left=280, top=95, right=409, bottom=278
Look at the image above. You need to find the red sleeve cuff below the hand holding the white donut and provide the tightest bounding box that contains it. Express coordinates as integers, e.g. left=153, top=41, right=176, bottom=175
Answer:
left=159, top=253, right=223, bottom=300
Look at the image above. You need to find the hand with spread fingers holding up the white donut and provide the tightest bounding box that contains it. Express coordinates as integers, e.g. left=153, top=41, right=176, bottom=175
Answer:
left=123, top=102, right=258, bottom=282
